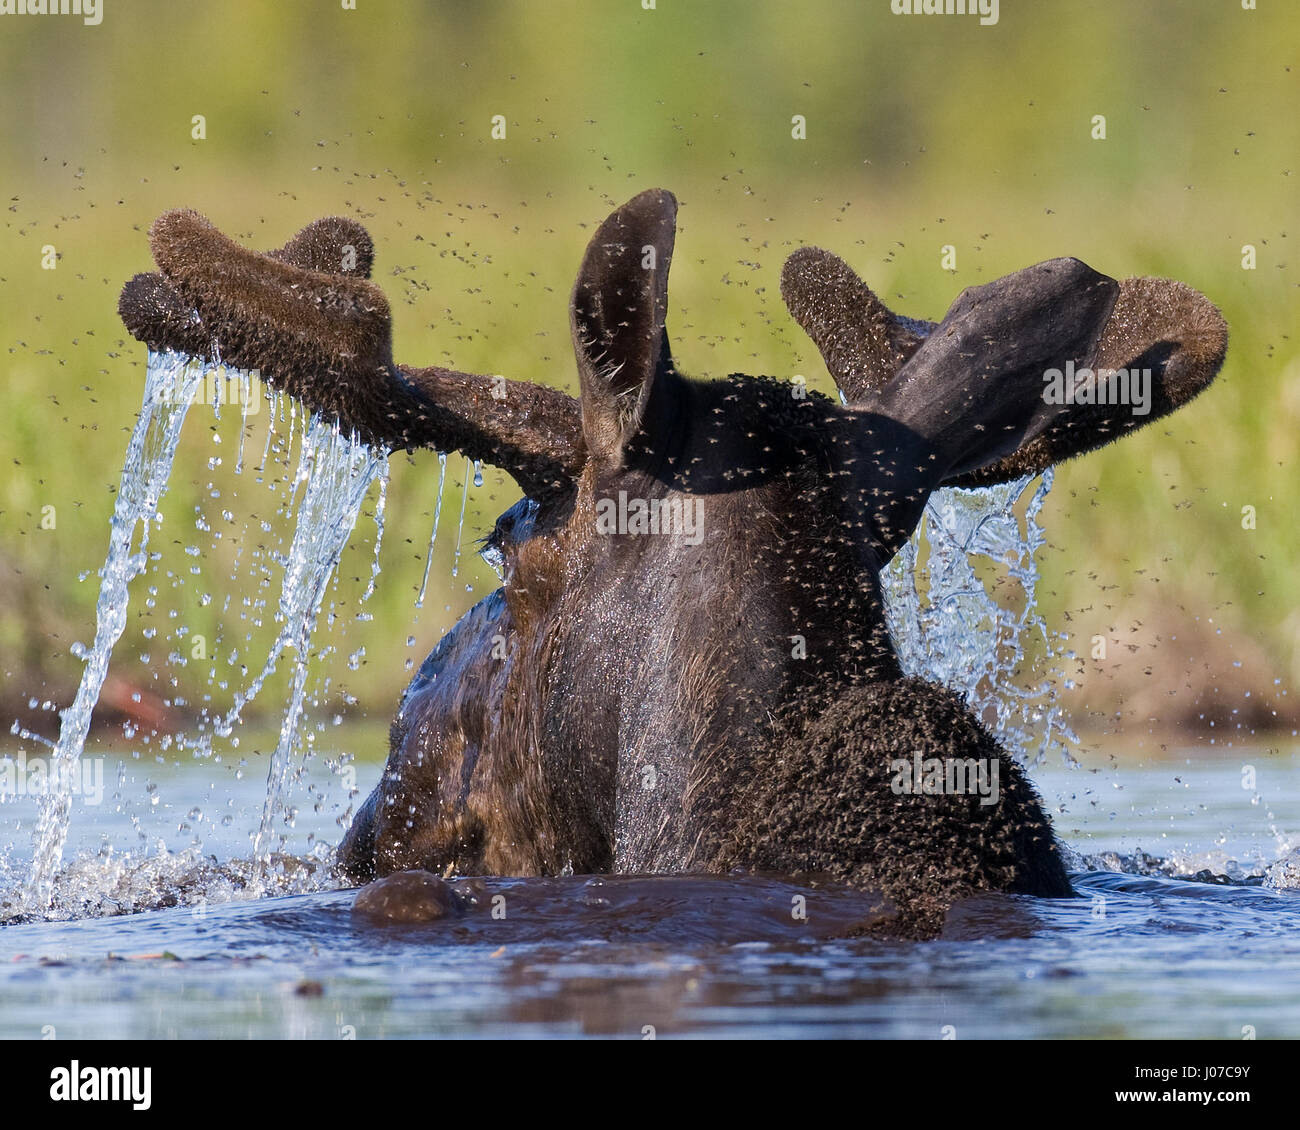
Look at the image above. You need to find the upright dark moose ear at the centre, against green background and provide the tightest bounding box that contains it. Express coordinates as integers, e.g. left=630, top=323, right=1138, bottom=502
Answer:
left=571, top=189, right=677, bottom=463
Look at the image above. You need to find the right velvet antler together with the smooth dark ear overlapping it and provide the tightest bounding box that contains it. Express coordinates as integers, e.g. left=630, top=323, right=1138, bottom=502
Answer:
left=781, top=247, right=1227, bottom=486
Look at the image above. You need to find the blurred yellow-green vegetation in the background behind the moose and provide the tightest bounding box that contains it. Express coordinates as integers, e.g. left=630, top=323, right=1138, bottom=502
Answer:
left=0, top=0, right=1300, bottom=748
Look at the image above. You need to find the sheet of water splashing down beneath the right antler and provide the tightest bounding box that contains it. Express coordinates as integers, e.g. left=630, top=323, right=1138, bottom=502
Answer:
left=880, top=469, right=1078, bottom=763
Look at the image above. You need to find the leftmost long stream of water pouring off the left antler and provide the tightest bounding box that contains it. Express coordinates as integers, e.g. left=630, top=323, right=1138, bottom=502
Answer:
left=23, top=351, right=203, bottom=910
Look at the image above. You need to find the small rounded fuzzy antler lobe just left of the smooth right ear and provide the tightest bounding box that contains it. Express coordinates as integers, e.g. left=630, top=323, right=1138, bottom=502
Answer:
left=781, top=247, right=935, bottom=404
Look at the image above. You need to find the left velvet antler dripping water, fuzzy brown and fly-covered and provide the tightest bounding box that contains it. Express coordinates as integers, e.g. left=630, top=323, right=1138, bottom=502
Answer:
left=118, top=211, right=585, bottom=499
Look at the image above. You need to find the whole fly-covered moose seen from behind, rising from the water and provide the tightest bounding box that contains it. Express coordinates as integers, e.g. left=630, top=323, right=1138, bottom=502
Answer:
left=120, top=190, right=1227, bottom=936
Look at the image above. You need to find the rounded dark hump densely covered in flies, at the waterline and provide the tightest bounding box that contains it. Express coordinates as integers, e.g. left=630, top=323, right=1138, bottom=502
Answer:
left=716, top=679, right=1073, bottom=926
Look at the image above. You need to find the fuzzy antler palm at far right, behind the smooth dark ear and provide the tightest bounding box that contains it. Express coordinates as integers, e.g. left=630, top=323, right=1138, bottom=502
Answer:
left=949, top=278, right=1227, bottom=486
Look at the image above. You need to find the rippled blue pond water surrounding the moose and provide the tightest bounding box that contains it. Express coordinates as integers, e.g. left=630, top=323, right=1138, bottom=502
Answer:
left=0, top=745, right=1300, bottom=1039
